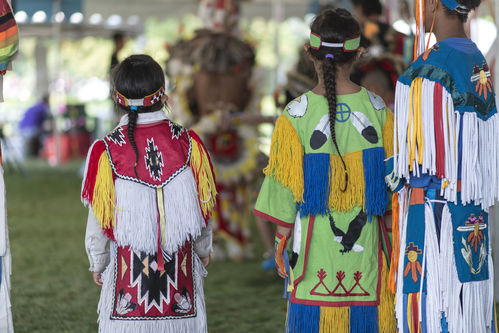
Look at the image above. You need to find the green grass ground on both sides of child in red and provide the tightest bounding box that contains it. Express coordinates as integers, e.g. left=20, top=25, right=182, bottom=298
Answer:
left=5, top=162, right=286, bottom=333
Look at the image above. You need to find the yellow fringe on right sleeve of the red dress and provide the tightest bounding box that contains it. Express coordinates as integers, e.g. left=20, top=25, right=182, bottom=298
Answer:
left=190, top=140, right=217, bottom=217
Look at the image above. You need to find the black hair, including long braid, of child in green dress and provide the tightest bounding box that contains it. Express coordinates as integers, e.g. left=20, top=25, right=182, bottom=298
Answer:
left=309, top=8, right=360, bottom=191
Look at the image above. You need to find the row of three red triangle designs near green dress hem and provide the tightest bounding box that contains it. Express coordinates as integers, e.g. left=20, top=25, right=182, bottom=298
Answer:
left=310, top=268, right=370, bottom=297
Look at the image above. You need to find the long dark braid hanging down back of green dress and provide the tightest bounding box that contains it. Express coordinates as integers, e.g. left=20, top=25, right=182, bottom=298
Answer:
left=322, top=57, right=348, bottom=192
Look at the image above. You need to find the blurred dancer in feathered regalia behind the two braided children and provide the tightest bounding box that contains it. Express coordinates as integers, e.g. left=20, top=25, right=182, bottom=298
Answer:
left=167, top=0, right=265, bottom=261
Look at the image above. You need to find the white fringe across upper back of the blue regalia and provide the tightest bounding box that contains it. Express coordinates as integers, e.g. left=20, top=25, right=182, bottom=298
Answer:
left=394, top=79, right=499, bottom=210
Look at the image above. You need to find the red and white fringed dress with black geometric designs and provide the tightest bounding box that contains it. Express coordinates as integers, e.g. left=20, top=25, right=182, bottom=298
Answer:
left=82, top=111, right=216, bottom=333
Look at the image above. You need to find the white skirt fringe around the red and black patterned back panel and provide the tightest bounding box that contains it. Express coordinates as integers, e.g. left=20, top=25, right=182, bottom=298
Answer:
left=97, top=243, right=208, bottom=333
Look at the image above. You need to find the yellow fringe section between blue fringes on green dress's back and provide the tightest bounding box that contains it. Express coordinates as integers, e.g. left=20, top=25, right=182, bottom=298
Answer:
left=329, top=151, right=365, bottom=212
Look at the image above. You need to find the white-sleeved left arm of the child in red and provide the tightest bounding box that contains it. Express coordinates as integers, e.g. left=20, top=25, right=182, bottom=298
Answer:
left=85, top=209, right=110, bottom=286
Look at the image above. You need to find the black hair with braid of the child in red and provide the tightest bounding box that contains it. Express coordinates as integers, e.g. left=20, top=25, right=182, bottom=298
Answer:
left=112, top=54, right=165, bottom=178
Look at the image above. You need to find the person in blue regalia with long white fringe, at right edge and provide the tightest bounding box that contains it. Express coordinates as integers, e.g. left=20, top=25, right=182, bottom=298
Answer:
left=390, top=0, right=499, bottom=333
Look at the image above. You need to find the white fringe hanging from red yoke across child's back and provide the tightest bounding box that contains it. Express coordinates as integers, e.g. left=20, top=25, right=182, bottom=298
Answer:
left=114, top=168, right=205, bottom=254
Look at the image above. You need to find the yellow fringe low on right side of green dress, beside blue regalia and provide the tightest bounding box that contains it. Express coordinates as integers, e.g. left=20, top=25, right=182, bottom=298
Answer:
left=378, top=254, right=397, bottom=333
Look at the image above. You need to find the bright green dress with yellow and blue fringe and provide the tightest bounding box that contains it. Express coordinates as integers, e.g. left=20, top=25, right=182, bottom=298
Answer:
left=254, top=88, right=396, bottom=333
